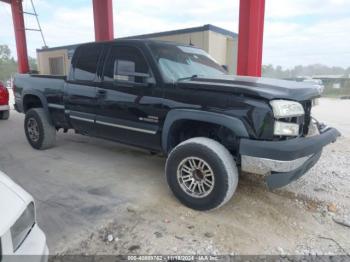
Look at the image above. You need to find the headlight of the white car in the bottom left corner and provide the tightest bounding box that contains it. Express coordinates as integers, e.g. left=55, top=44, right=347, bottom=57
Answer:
left=11, top=202, right=35, bottom=252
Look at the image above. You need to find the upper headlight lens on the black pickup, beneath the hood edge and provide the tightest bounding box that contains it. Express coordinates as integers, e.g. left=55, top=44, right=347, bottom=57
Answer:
left=270, top=100, right=305, bottom=118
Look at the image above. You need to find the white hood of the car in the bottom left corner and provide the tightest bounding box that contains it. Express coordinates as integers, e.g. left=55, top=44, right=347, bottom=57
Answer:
left=0, top=171, right=32, bottom=237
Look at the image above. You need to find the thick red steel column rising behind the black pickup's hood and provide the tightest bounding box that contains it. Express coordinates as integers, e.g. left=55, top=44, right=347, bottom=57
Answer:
left=237, top=0, right=265, bottom=77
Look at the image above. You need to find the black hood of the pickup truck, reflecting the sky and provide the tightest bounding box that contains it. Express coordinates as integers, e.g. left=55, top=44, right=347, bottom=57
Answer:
left=177, top=75, right=322, bottom=101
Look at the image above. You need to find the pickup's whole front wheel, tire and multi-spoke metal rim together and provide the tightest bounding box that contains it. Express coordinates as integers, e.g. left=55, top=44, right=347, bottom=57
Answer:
left=166, top=137, right=238, bottom=210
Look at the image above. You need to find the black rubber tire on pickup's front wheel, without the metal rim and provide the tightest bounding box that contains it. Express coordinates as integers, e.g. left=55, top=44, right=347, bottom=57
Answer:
left=165, top=137, right=239, bottom=211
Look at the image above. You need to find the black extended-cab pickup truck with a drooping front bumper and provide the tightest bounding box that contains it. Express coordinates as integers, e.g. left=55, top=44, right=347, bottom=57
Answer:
left=14, top=39, right=340, bottom=210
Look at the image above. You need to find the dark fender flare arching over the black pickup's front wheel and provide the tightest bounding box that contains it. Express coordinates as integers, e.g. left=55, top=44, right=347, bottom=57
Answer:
left=162, top=109, right=249, bottom=154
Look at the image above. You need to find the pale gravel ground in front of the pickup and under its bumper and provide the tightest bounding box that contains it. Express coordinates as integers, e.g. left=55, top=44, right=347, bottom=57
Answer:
left=57, top=99, right=350, bottom=255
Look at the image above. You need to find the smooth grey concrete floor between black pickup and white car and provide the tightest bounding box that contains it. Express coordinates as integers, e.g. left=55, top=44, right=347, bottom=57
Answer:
left=0, top=111, right=167, bottom=249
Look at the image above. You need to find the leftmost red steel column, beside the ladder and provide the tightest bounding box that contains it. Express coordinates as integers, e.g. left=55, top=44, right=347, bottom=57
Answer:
left=11, top=0, right=29, bottom=74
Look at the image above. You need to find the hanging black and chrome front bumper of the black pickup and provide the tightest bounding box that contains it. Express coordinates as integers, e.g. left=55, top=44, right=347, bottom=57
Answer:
left=239, top=123, right=340, bottom=189
